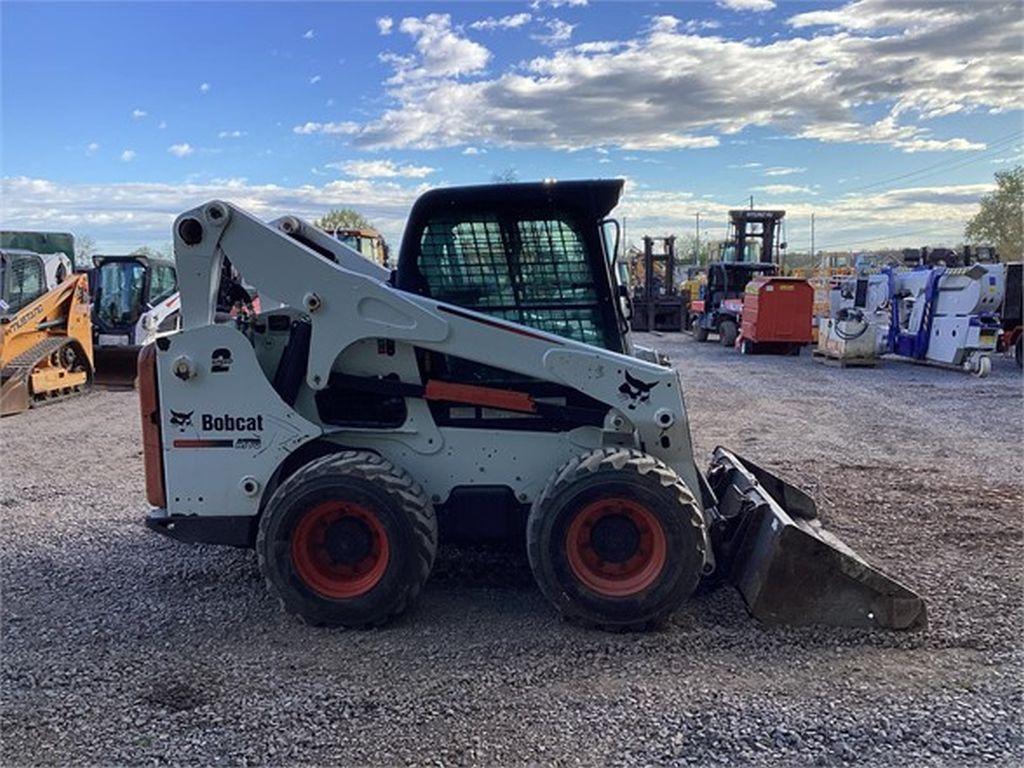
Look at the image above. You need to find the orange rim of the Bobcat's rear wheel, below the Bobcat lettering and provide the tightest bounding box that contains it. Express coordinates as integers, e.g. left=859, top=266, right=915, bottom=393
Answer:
left=292, top=502, right=390, bottom=600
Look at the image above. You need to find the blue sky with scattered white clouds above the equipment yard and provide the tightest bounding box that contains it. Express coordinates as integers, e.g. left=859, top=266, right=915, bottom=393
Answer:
left=0, top=0, right=1024, bottom=250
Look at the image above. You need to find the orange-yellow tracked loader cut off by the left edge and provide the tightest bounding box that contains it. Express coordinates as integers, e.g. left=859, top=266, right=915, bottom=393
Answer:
left=0, top=248, right=92, bottom=416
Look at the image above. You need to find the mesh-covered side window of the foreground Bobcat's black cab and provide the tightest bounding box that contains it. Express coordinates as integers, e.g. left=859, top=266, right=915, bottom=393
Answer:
left=420, top=217, right=605, bottom=346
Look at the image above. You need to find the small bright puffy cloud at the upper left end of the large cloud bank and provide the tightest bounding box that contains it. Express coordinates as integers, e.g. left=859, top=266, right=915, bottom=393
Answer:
left=385, top=13, right=490, bottom=84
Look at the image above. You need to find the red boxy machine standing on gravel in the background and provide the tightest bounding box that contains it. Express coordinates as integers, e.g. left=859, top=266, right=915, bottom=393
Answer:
left=736, top=275, right=814, bottom=354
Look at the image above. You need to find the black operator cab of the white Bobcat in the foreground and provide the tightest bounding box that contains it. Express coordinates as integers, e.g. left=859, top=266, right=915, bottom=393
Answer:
left=395, top=179, right=628, bottom=352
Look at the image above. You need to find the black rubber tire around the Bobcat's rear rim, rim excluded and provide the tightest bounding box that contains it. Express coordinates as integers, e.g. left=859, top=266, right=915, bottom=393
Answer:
left=256, top=451, right=437, bottom=628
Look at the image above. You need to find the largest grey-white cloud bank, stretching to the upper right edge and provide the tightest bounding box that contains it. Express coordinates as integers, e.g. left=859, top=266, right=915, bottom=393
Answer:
left=329, top=0, right=1024, bottom=152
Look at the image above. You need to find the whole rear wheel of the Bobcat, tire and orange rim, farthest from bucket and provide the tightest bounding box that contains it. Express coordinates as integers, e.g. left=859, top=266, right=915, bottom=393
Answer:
left=256, top=451, right=437, bottom=627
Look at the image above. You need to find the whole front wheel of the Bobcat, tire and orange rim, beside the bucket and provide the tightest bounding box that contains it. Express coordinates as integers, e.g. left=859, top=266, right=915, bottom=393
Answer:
left=526, top=449, right=707, bottom=630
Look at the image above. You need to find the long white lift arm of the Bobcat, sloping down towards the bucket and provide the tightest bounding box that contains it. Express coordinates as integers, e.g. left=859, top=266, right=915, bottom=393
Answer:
left=174, top=201, right=700, bottom=488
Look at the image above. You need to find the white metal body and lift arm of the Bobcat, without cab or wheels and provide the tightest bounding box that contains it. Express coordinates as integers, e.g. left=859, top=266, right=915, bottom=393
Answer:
left=157, top=202, right=701, bottom=528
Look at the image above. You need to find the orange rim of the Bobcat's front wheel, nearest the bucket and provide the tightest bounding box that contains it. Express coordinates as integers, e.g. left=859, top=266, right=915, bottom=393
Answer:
left=565, top=498, right=668, bottom=597
